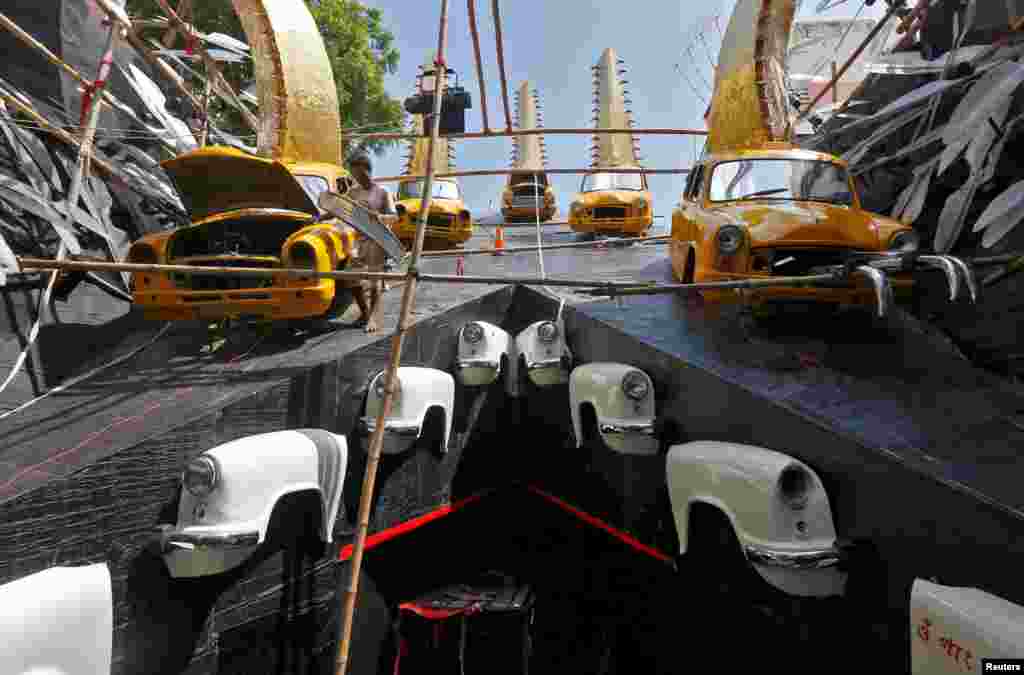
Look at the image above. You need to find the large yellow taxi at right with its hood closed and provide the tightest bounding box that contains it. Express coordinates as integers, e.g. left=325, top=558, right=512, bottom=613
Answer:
left=670, top=143, right=920, bottom=304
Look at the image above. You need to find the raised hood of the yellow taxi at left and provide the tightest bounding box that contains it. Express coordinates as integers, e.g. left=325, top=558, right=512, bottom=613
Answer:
left=161, top=146, right=318, bottom=221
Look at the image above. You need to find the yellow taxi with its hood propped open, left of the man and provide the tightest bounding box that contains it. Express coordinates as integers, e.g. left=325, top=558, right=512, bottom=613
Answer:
left=127, top=146, right=356, bottom=321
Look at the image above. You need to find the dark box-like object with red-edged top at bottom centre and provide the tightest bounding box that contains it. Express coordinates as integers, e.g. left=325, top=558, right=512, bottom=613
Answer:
left=393, top=577, right=535, bottom=675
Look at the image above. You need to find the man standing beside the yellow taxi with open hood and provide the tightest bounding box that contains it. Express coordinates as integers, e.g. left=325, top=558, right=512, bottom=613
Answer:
left=348, top=153, right=397, bottom=333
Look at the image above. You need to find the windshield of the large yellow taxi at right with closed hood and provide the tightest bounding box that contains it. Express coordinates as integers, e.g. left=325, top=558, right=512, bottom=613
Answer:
left=711, top=159, right=853, bottom=206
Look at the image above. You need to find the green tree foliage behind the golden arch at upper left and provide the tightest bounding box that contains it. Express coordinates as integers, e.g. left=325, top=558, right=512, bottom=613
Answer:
left=128, top=0, right=403, bottom=155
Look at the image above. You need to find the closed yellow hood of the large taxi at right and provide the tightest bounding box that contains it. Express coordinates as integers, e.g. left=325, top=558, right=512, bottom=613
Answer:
left=711, top=202, right=879, bottom=250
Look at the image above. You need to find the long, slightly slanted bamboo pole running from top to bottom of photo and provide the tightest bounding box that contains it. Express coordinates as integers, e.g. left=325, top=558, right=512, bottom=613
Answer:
left=337, top=0, right=449, bottom=675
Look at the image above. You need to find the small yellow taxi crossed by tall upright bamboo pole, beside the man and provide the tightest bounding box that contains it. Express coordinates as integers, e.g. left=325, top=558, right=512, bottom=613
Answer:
left=392, top=178, right=473, bottom=249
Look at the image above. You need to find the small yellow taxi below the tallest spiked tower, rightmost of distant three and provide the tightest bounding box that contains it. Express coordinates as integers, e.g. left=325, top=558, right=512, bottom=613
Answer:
left=568, top=168, right=654, bottom=237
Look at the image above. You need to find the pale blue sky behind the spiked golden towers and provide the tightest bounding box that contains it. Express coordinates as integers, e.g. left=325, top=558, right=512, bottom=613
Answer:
left=364, top=0, right=886, bottom=230
